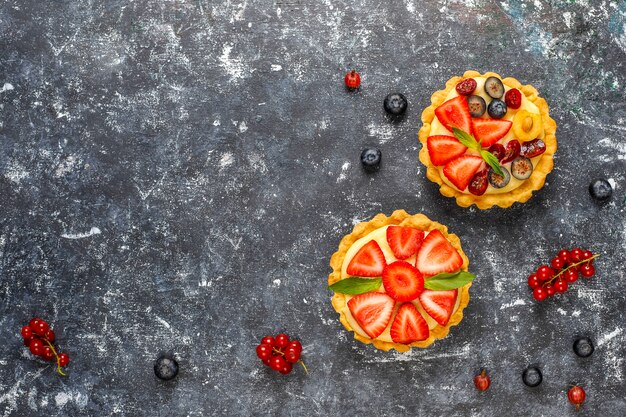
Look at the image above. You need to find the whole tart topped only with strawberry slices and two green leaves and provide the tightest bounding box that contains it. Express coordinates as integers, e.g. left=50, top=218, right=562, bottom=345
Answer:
left=328, top=210, right=474, bottom=352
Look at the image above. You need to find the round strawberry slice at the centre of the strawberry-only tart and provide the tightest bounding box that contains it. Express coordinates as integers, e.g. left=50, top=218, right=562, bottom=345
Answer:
left=383, top=261, right=424, bottom=301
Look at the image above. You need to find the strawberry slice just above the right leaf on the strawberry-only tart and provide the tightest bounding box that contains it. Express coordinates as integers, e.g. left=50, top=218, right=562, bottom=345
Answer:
left=415, top=230, right=463, bottom=276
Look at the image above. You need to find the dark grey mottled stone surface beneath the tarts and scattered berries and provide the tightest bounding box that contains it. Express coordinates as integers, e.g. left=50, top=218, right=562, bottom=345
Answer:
left=0, top=0, right=626, bottom=417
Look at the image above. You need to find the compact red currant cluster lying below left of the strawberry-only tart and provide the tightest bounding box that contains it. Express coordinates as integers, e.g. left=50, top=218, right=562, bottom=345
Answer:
left=256, top=333, right=308, bottom=375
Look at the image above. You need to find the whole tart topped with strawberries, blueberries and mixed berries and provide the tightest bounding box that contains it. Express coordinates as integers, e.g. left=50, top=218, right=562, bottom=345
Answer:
left=419, top=71, right=557, bottom=210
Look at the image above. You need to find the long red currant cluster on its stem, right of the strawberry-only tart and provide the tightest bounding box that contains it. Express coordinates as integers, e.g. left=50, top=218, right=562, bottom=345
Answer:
left=528, top=248, right=600, bottom=301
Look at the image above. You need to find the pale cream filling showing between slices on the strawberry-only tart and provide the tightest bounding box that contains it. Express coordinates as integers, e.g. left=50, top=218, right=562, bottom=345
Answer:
left=341, top=226, right=461, bottom=342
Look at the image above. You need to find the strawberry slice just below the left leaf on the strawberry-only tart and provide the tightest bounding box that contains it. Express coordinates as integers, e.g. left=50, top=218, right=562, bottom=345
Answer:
left=348, top=292, right=396, bottom=339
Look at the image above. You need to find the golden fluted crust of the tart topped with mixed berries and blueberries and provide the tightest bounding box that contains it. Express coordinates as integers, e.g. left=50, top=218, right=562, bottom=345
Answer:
left=418, top=71, right=557, bottom=210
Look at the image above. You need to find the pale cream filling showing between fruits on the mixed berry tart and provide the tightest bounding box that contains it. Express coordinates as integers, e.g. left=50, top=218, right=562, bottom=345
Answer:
left=430, top=77, right=545, bottom=194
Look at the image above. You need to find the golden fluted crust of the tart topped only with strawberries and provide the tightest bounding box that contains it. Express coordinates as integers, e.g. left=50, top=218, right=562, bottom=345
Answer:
left=328, top=210, right=472, bottom=352
